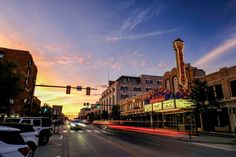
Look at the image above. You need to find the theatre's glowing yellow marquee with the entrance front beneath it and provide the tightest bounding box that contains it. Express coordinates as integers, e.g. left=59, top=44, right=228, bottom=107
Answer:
left=144, top=99, right=195, bottom=131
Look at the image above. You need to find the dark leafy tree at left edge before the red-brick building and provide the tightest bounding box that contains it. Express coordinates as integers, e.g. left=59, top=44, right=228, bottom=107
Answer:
left=0, top=61, right=22, bottom=116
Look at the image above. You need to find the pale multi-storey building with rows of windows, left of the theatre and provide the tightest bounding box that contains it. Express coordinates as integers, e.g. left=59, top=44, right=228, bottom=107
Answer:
left=99, top=75, right=162, bottom=113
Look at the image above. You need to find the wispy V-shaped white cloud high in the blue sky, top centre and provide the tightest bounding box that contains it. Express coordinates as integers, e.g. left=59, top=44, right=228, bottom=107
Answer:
left=105, top=1, right=170, bottom=41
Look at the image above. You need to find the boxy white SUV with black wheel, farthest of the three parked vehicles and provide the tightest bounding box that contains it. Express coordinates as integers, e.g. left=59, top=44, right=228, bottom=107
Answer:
left=5, top=117, right=53, bottom=145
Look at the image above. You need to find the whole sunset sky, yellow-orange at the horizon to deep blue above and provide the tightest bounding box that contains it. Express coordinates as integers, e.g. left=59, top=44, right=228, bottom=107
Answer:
left=0, top=0, right=236, bottom=113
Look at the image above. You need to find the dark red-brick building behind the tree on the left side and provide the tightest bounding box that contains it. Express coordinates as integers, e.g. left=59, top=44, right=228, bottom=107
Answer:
left=0, top=48, right=37, bottom=116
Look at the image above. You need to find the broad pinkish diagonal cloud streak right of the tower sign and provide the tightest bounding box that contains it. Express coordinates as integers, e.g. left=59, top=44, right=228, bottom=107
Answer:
left=193, top=38, right=236, bottom=66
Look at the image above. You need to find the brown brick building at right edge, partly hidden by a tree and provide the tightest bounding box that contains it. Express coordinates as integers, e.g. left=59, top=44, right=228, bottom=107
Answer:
left=199, top=66, right=236, bottom=132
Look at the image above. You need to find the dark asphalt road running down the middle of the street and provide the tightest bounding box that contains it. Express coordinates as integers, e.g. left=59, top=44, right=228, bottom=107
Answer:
left=35, top=126, right=236, bottom=157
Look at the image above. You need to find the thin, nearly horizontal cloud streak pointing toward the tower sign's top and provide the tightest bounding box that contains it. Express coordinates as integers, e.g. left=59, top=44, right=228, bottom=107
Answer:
left=106, top=29, right=179, bottom=41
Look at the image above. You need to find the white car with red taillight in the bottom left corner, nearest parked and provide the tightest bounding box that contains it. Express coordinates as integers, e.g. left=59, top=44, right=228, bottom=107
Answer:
left=0, top=126, right=31, bottom=157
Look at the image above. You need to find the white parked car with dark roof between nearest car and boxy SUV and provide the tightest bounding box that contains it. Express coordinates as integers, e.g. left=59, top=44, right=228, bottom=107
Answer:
left=0, top=123, right=39, bottom=157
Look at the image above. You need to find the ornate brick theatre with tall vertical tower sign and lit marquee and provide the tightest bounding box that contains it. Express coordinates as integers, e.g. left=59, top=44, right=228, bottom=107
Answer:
left=120, top=39, right=205, bottom=130
